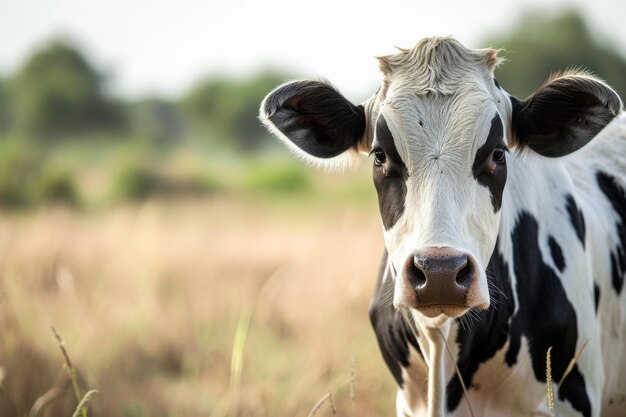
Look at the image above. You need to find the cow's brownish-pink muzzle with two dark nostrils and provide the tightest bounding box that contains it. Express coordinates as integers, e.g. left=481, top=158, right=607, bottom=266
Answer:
left=394, top=247, right=482, bottom=318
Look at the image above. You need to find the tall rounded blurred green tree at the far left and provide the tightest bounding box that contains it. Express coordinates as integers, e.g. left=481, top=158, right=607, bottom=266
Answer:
left=12, top=41, right=122, bottom=137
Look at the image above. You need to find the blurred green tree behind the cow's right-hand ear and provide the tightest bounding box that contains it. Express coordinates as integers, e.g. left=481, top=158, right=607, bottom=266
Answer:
left=488, top=10, right=626, bottom=98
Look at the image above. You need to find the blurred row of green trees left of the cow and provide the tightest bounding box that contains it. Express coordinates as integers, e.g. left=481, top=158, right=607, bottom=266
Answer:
left=0, top=40, right=288, bottom=151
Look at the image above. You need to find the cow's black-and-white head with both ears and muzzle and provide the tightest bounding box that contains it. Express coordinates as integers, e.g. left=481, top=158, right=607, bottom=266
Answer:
left=260, top=38, right=622, bottom=327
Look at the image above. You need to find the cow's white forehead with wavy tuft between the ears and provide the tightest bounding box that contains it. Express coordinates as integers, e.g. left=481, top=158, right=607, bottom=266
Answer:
left=367, top=37, right=507, bottom=162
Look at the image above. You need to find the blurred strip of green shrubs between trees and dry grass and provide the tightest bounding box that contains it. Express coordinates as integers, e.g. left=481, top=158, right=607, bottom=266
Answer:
left=0, top=133, right=375, bottom=210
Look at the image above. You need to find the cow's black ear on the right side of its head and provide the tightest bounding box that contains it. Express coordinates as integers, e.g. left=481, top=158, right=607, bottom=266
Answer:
left=511, top=72, right=623, bottom=157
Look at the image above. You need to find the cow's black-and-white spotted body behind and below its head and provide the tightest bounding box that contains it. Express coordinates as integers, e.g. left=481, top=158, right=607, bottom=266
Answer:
left=370, top=112, right=626, bottom=417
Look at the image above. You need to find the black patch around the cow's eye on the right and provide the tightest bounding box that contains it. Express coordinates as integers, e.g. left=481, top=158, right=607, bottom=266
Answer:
left=472, top=113, right=506, bottom=212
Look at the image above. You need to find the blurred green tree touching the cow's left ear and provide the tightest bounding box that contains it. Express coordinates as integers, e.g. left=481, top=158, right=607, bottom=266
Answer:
left=181, top=72, right=288, bottom=151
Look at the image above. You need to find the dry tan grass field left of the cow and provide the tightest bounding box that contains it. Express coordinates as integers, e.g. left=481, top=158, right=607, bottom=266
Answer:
left=0, top=184, right=395, bottom=417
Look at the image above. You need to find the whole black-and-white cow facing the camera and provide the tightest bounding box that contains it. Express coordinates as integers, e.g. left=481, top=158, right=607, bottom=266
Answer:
left=260, top=38, right=626, bottom=417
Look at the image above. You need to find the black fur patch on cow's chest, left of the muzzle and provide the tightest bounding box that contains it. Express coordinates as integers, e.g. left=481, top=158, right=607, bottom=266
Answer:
left=369, top=251, right=421, bottom=387
